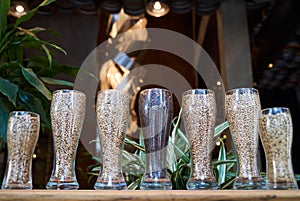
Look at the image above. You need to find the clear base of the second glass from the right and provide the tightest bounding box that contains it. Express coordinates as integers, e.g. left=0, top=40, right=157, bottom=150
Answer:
left=233, top=177, right=265, bottom=190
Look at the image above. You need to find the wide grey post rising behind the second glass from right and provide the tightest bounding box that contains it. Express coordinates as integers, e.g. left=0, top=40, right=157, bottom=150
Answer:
left=217, top=0, right=253, bottom=90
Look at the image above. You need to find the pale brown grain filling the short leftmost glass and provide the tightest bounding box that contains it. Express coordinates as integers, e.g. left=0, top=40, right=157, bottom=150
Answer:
left=2, top=112, right=40, bottom=188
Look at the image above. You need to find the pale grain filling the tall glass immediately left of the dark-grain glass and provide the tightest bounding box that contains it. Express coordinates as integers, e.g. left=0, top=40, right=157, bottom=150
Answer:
left=96, top=90, right=130, bottom=185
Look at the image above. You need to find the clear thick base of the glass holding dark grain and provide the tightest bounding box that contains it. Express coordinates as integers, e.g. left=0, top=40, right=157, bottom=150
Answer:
left=141, top=179, right=172, bottom=190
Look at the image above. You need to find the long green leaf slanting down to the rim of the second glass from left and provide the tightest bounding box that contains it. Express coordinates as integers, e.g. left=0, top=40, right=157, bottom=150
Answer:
left=21, top=67, right=52, bottom=100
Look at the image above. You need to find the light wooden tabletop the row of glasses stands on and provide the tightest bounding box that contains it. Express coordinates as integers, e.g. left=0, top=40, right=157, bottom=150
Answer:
left=0, top=190, right=300, bottom=201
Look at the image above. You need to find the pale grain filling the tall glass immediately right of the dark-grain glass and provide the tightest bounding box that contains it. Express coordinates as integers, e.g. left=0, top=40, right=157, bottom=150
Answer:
left=182, top=93, right=216, bottom=181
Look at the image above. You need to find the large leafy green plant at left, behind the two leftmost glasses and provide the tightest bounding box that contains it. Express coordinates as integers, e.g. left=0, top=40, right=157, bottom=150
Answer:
left=0, top=0, right=78, bottom=148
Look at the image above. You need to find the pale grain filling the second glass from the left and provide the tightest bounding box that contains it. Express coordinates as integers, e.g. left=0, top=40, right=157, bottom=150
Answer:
left=50, top=91, right=86, bottom=183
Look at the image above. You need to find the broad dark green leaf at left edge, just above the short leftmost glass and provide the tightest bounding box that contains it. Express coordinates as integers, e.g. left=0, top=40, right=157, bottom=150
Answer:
left=0, top=77, right=19, bottom=106
